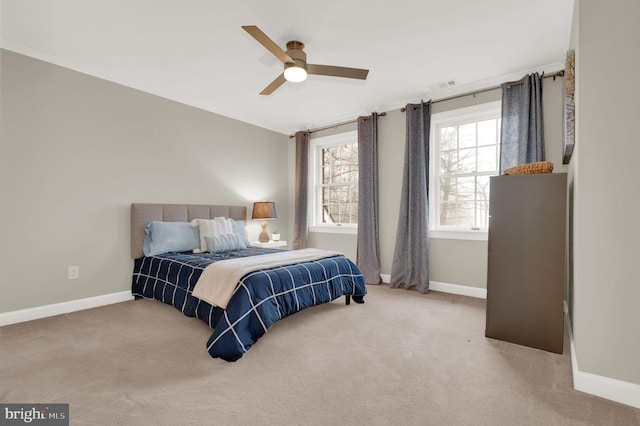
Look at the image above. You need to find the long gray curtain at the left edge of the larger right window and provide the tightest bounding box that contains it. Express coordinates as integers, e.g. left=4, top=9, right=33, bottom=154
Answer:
left=391, top=102, right=431, bottom=293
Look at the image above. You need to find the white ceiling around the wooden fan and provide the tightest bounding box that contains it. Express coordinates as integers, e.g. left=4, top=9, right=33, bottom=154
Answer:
left=0, top=0, right=573, bottom=134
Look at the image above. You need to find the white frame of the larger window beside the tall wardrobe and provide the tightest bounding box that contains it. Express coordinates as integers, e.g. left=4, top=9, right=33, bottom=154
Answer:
left=429, top=101, right=502, bottom=241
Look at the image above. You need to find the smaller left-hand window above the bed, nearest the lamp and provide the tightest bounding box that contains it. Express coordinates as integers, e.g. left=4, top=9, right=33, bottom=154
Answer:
left=309, top=131, right=358, bottom=232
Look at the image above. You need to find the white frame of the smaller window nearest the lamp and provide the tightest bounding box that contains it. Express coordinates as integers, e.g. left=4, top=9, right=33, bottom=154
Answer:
left=308, top=130, right=358, bottom=234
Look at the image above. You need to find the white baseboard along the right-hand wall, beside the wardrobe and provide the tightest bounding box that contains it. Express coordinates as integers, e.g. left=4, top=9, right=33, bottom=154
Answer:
left=565, top=302, right=640, bottom=408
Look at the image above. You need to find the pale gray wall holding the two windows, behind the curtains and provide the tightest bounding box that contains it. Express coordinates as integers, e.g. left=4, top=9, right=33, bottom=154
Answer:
left=290, top=78, right=567, bottom=288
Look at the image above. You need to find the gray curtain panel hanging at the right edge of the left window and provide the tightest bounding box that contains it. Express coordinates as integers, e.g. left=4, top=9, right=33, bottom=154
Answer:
left=356, top=113, right=381, bottom=284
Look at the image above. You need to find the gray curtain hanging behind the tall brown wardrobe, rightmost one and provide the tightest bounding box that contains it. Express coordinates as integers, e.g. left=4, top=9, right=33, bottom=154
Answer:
left=500, top=73, right=545, bottom=174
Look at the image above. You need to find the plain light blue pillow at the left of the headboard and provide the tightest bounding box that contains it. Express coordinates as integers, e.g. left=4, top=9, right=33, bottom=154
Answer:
left=143, top=221, right=200, bottom=256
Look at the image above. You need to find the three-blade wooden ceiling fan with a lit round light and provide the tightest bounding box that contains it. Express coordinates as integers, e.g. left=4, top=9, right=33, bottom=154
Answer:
left=242, top=25, right=369, bottom=95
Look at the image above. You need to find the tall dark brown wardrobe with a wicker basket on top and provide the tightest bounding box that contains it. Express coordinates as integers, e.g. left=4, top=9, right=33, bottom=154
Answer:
left=485, top=173, right=567, bottom=353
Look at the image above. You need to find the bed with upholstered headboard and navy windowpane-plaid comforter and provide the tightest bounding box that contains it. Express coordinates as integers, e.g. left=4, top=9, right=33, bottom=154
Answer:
left=131, top=203, right=366, bottom=361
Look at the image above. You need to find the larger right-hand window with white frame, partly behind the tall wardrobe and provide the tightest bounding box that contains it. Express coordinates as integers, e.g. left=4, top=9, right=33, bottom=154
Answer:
left=429, top=102, right=500, bottom=239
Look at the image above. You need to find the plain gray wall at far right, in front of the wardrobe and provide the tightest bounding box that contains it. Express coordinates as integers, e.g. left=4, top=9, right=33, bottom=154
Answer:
left=570, top=0, right=640, bottom=384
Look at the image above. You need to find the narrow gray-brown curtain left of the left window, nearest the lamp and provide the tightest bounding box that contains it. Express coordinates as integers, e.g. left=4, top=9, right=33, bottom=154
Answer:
left=291, top=131, right=309, bottom=250
